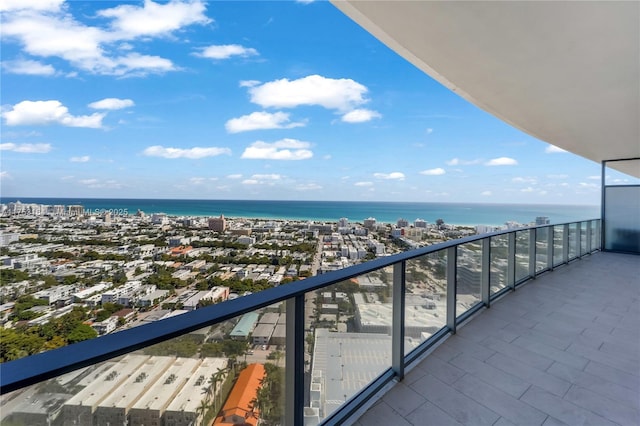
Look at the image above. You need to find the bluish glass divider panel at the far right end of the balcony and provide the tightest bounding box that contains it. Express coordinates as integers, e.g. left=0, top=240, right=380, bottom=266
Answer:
left=604, top=186, right=640, bottom=253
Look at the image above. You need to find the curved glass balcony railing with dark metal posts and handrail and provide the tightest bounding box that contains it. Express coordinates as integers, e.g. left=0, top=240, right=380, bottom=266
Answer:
left=0, top=220, right=600, bottom=426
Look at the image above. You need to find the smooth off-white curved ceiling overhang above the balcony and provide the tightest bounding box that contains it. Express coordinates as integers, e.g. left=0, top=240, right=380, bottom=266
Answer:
left=332, top=0, right=640, bottom=177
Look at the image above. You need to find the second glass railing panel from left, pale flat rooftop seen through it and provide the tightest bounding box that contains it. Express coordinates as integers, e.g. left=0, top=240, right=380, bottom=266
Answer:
left=304, top=272, right=393, bottom=424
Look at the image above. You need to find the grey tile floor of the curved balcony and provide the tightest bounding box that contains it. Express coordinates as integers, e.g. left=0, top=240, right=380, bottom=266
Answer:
left=355, top=253, right=640, bottom=426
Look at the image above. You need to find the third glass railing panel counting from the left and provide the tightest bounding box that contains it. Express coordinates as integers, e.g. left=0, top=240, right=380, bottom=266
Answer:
left=404, top=250, right=447, bottom=353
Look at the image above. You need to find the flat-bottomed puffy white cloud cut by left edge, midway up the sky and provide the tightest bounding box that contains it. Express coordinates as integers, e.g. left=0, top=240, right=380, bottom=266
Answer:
left=2, top=100, right=105, bottom=129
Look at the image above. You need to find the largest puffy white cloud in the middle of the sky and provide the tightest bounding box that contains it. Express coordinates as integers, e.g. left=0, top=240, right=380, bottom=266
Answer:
left=249, top=75, right=368, bottom=112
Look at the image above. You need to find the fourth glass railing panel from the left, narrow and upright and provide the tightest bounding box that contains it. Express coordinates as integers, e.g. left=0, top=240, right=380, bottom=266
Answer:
left=456, top=241, right=482, bottom=317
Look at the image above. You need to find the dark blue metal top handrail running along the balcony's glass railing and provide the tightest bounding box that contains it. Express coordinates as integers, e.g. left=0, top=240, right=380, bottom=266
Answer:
left=0, top=219, right=599, bottom=406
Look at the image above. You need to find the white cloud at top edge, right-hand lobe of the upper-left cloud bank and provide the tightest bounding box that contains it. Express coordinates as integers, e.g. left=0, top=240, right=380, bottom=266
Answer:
left=98, top=0, right=211, bottom=39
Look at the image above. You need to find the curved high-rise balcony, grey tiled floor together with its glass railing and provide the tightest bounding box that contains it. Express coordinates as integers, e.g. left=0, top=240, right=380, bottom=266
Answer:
left=0, top=220, right=640, bottom=425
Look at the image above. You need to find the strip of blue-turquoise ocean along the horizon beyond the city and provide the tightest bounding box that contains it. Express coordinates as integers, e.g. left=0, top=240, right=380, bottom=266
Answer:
left=0, top=197, right=600, bottom=226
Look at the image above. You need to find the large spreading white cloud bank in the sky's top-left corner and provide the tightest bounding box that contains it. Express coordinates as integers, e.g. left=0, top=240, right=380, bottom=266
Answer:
left=3, top=0, right=210, bottom=76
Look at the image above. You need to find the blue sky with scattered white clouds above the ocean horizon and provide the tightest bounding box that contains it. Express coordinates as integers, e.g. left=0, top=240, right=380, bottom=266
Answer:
left=0, top=0, right=624, bottom=204
